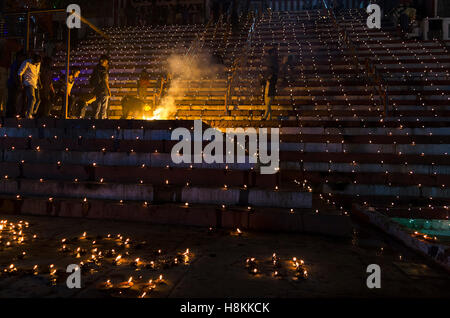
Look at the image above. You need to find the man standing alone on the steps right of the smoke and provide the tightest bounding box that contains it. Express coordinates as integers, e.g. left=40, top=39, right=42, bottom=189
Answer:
left=262, top=48, right=279, bottom=120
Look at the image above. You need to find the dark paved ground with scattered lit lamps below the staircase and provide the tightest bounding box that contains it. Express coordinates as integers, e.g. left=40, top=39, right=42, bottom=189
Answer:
left=0, top=215, right=450, bottom=298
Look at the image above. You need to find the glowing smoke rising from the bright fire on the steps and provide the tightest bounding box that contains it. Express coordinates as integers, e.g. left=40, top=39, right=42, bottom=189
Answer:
left=154, top=51, right=226, bottom=119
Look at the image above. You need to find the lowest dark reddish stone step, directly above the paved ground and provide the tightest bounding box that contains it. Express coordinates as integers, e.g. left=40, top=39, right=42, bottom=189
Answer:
left=0, top=196, right=352, bottom=237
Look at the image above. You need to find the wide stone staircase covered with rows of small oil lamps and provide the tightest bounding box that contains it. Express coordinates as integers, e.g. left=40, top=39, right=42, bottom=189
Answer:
left=0, top=10, right=450, bottom=235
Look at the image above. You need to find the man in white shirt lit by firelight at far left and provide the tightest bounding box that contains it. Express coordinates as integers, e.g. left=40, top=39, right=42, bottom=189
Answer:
left=17, top=54, right=42, bottom=118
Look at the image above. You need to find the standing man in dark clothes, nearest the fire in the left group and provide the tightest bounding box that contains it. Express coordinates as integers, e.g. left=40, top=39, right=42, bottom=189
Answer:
left=90, top=55, right=111, bottom=119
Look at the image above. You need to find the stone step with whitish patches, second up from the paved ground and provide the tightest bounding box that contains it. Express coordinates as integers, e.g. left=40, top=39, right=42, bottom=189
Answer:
left=0, top=179, right=312, bottom=209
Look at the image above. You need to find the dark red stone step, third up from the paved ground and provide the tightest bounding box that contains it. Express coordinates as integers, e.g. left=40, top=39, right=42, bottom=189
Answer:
left=0, top=162, right=278, bottom=190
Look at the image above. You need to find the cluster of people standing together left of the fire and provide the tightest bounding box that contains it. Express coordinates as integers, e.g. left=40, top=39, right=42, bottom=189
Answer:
left=3, top=51, right=111, bottom=119
